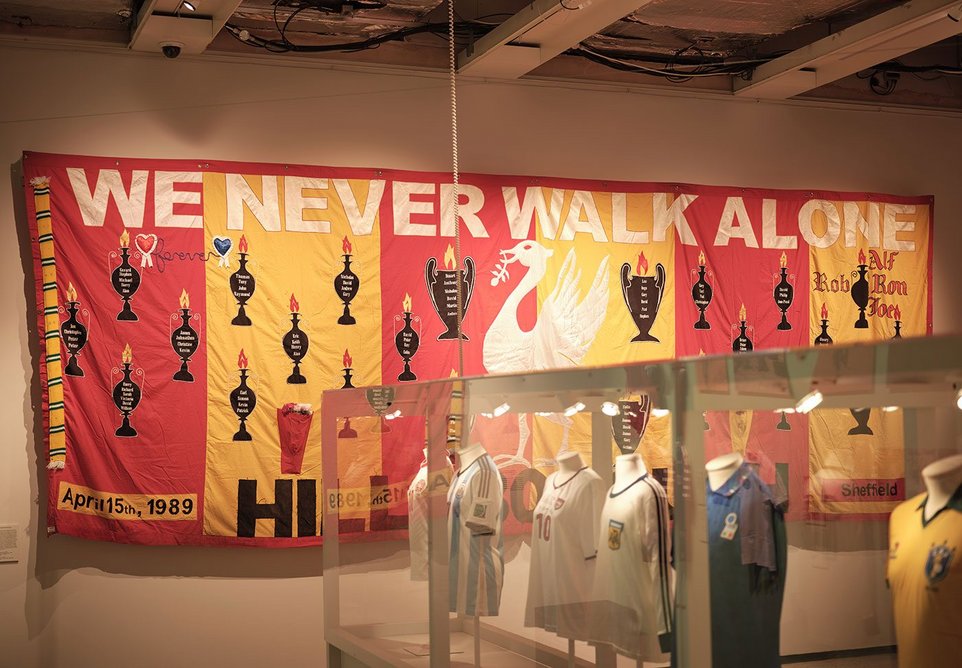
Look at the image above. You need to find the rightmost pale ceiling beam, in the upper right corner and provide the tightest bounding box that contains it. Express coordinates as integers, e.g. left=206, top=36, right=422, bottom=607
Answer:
left=734, top=0, right=962, bottom=100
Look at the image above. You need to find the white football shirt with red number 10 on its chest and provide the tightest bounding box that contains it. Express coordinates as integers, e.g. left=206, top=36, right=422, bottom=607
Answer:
left=524, top=467, right=605, bottom=640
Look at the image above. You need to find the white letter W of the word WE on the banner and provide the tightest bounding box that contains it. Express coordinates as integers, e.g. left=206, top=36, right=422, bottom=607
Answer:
left=67, top=167, right=150, bottom=227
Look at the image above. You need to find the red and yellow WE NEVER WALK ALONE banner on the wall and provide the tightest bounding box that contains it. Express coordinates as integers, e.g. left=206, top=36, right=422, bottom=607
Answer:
left=23, top=153, right=932, bottom=546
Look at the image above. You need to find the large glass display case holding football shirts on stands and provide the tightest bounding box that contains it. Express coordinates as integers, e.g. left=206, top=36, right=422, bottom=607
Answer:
left=322, top=336, right=962, bottom=668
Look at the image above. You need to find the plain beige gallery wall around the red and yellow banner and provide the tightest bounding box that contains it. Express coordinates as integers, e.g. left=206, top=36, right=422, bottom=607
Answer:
left=0, top=44, right=962, bottom=668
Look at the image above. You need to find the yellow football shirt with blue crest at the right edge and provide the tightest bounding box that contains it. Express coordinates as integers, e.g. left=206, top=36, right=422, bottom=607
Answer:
left=888, top=487, right=962, bottom=668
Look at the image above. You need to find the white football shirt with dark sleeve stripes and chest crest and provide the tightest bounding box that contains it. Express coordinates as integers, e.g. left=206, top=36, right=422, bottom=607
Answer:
left=590, top=473, right=674, bottom=661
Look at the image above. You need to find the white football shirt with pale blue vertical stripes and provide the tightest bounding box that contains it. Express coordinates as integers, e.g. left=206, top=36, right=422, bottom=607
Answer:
left=448, top=454, right=504, bottom=617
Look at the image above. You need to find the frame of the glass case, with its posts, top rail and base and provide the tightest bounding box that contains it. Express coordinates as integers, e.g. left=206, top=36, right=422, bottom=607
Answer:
left=322, top=336, right=962, bottom=668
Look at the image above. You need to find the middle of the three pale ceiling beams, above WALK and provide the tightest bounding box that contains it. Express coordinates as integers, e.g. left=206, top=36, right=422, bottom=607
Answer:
left=458, top=0, right=652, bottom=79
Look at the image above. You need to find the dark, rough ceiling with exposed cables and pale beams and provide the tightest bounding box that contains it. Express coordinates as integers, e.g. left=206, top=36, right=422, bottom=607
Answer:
left=0, top=0, right=962, bottom=110
